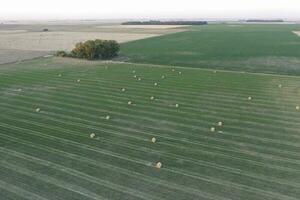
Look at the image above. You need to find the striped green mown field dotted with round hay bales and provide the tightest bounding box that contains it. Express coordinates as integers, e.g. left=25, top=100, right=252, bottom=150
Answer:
left=0, top=57, right=300, bottom=200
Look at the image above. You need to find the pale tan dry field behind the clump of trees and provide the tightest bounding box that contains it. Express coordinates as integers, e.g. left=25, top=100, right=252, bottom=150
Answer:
left=0, top=22, right=185, bottom=64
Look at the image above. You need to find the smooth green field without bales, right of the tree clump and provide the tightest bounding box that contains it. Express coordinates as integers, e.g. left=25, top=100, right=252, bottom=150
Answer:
left=122, top=24, right=300, bottom=75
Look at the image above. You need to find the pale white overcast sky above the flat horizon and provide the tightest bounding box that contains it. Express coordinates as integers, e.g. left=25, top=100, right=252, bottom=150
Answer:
left=0, top=0, right=300, bottom=20
